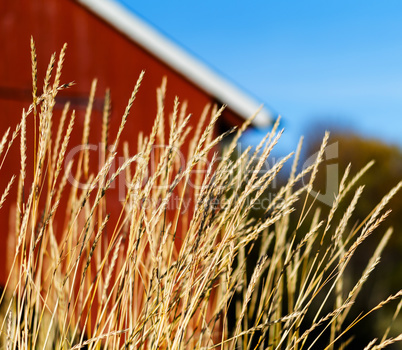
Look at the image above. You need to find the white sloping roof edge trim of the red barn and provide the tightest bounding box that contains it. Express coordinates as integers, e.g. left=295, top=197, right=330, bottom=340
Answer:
left=77, top=0, right=273, bottom=127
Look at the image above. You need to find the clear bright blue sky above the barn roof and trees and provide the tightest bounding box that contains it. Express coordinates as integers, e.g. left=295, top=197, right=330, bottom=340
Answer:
left=119, top=0, right=402, bottom=152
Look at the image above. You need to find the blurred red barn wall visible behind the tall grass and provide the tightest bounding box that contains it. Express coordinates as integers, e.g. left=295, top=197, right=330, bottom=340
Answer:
left=0, top=0, right=241, bottom=285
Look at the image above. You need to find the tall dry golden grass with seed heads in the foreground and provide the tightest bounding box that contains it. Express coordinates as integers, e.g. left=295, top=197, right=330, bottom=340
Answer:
left=0, top=42, right=402, bottom=349
